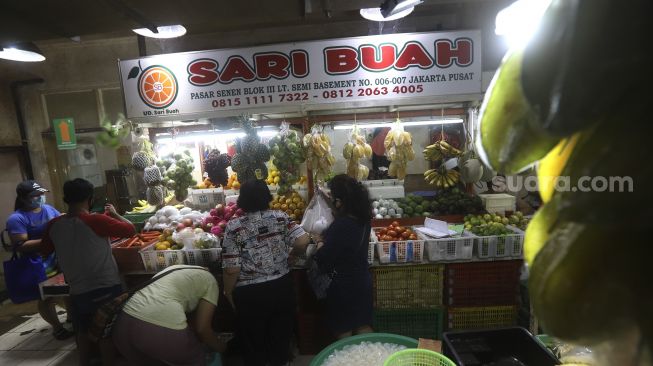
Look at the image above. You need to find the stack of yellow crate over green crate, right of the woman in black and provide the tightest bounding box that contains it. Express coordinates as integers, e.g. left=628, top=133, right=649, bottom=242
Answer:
left=372, top=264, right=445, bottom=339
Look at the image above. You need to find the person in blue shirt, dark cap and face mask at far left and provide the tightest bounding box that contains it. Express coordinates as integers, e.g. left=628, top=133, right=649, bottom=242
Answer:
left=7, top=180, right=73, bottom=340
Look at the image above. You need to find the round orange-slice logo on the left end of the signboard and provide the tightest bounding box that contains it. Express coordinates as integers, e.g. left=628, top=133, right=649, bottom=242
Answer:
left=138, top=65, right=178, bottom=109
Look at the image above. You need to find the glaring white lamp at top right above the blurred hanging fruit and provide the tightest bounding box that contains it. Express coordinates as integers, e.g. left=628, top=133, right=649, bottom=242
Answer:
left=494, top=0, right=551, bottom=48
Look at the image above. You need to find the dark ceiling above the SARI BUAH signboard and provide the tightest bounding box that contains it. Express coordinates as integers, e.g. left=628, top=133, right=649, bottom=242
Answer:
left=0, top=0, right=510, bottom=46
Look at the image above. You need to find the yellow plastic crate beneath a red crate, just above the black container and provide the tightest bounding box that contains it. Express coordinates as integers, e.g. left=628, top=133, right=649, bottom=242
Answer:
left=447, top=306, right=517, bottom=330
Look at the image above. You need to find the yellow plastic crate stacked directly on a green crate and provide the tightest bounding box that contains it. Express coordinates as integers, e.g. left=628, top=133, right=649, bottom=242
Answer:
left=372, top=264, right=444, bottom=309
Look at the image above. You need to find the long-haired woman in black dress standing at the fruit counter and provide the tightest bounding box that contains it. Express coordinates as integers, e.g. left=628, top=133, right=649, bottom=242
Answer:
left=315, top=174, right=372, bottom=338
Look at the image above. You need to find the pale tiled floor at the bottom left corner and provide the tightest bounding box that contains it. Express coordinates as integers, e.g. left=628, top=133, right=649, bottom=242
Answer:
left=0, top=314, right=313, bottom=366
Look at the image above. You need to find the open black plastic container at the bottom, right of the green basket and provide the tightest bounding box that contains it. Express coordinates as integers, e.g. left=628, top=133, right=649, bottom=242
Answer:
left=443, top=327, right=560, bottom=366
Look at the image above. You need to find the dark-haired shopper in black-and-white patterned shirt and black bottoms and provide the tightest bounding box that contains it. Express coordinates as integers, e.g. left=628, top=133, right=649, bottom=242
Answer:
left=222, top=180, right=310, bottom=366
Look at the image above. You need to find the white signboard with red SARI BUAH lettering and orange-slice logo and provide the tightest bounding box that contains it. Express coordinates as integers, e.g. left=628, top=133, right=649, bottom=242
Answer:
left=119, top=31, right=481, bottom=119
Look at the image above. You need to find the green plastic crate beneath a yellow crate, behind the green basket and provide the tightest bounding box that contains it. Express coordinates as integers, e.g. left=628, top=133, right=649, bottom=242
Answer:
left=373, top=307, right=445, bottom=339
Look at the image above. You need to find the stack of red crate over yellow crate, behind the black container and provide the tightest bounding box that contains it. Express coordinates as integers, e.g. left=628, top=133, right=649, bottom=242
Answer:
left=445, top=260, right=523, bottom=330
